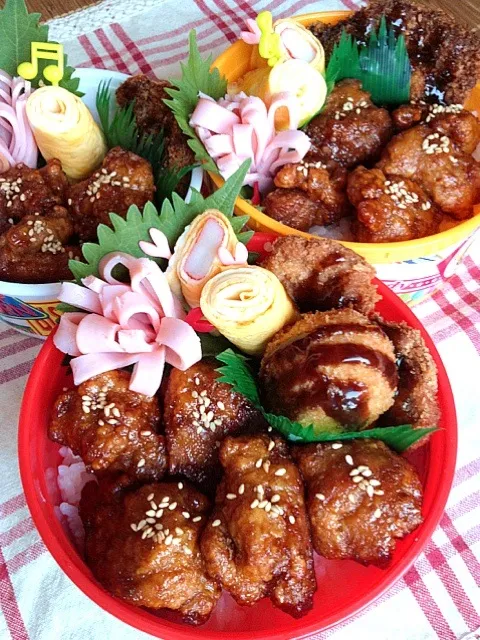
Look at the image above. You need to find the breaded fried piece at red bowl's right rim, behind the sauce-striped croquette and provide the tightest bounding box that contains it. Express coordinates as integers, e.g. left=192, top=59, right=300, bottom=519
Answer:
left=378, top=319, right=440, bottom=432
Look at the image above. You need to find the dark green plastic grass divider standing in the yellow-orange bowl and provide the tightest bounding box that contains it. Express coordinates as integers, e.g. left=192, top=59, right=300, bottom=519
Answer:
left=326, top=16, right=411, bottom=104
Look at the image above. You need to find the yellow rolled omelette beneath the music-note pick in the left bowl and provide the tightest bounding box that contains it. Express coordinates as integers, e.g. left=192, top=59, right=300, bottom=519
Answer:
left=27, top=86, right=107, bottom=181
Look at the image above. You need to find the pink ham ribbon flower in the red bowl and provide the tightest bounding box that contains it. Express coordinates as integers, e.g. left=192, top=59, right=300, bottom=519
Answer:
left=53, top=252, right=202, bottom=396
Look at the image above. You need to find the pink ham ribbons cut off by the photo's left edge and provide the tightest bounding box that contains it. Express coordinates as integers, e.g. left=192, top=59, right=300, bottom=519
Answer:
left=0, top=71, right=38, bottom=173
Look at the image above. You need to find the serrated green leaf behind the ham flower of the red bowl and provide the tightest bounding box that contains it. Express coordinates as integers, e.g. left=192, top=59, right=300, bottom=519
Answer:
left=68, top=160, right=251, bottom=280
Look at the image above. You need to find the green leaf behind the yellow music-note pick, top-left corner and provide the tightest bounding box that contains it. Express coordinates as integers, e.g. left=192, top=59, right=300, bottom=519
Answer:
left=0, top=0, right=83, bottom=97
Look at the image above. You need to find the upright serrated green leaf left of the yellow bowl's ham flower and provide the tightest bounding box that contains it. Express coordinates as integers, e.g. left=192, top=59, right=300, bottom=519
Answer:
left=164, top=29, right=227, bottom=173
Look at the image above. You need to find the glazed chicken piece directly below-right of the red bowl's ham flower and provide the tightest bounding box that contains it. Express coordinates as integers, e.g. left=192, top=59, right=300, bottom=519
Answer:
left=164, top=360, right=260, bottom=491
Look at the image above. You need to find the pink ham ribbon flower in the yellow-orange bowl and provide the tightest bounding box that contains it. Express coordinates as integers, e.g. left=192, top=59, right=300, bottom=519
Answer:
left=190, top=92, right=310, bottom=193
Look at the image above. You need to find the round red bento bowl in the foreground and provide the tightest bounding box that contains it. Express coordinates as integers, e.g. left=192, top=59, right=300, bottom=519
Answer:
left=19, top=281, right=457, bottom=640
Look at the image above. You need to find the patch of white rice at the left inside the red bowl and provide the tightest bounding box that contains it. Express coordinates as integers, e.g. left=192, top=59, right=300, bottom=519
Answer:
left=55, top=447, right=95, bottom=549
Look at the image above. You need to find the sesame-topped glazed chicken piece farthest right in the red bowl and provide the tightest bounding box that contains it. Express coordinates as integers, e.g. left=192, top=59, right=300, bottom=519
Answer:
left=293, top=440, right=422, bottom=567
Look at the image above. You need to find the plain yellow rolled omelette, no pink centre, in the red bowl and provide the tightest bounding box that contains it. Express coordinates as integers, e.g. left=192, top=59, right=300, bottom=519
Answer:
left=200, top=266, right=297, bottom=356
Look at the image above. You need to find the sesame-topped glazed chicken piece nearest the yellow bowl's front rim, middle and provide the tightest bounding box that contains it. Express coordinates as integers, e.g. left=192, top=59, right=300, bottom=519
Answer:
left=347, top=167, right=442, bottom=242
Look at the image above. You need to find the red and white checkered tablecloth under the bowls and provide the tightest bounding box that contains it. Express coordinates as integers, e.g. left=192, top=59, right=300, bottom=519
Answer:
left=0, top=0, right=480, bottom=640
